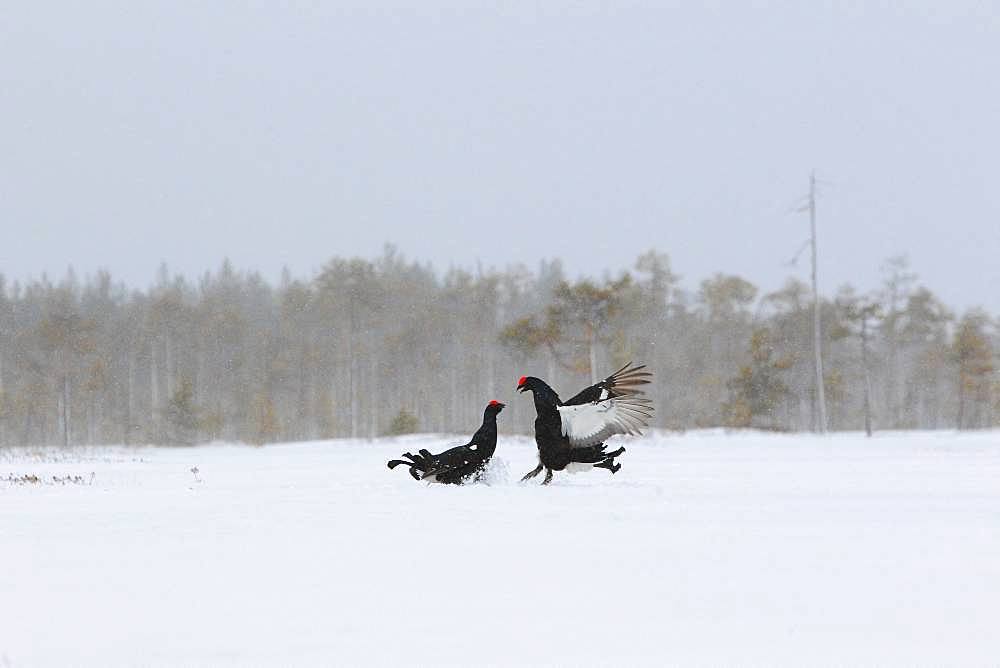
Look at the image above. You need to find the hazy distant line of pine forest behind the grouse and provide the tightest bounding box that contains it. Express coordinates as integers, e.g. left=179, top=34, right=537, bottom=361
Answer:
left=0, top=247, right=1000, bottom=445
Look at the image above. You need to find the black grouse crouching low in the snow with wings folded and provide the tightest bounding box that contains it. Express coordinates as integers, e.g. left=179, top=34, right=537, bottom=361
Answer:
left=389, top=401, right=504, bottom=485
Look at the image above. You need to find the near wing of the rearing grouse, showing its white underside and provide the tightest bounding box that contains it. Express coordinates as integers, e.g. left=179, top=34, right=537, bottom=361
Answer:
left=558, top=394, right=653, bottom=448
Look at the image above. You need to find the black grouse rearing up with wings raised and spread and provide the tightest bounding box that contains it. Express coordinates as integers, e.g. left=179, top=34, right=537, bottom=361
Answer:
left=517, top=362, right=653, bottom=485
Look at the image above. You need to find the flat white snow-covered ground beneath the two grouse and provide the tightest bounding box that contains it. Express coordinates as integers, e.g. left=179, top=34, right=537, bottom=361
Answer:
left=0, top=432, right=1000, bottom=666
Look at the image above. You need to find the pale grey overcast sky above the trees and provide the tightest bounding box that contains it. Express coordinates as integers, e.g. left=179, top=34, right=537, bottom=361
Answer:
left=0, top=1, right=1000, bottom=313
